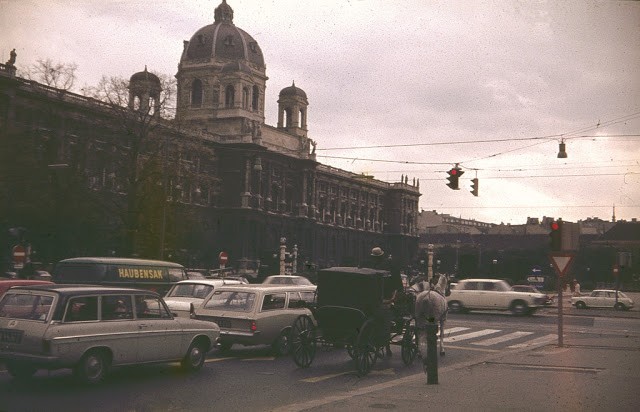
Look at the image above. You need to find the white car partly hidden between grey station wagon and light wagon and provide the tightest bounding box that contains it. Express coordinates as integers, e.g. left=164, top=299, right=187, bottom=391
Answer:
left=164, top=279, right=242, bottom=318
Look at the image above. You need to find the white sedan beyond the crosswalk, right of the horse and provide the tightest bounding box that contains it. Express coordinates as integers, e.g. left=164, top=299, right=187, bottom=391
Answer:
left=447, top=279, right=547, bottom=315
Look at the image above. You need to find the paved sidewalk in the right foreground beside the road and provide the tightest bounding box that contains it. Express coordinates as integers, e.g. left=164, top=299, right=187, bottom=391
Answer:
left=276, top=324, right=640, bottom=412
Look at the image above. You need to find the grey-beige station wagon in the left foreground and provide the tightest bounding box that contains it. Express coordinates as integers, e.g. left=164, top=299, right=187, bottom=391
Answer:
left=0, top=285, right=220, bottom=383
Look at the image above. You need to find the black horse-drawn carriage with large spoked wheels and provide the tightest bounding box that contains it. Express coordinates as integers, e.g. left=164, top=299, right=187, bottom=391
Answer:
left=291, top=267, right=418, bottom=375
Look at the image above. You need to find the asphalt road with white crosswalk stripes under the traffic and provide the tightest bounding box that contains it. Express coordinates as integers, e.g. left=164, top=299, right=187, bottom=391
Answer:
left=0, top=308, right=640, bottom=411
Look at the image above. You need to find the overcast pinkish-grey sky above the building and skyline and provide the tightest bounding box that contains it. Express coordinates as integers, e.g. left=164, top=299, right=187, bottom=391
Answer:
left=0, top=0, right=640, bottom=224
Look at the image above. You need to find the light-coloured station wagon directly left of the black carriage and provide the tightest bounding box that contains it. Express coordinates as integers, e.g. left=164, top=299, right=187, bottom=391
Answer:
left=192, top=284, right=316, bottom=355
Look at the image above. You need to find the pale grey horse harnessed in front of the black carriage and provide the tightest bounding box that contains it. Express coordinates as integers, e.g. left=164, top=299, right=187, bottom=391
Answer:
left=414, top=274, right=451, bottom=360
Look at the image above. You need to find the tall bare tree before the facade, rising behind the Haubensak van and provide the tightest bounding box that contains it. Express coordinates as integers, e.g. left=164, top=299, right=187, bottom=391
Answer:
left=84, top=73, right=212, bottom=258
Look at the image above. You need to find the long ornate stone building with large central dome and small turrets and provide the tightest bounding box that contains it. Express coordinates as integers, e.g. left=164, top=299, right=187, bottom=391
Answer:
left=0, top=0, right=420, bottom=275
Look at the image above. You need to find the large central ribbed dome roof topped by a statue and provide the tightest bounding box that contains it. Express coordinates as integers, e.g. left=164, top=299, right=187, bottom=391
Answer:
left=182, top=0, right=265, bottom=69
